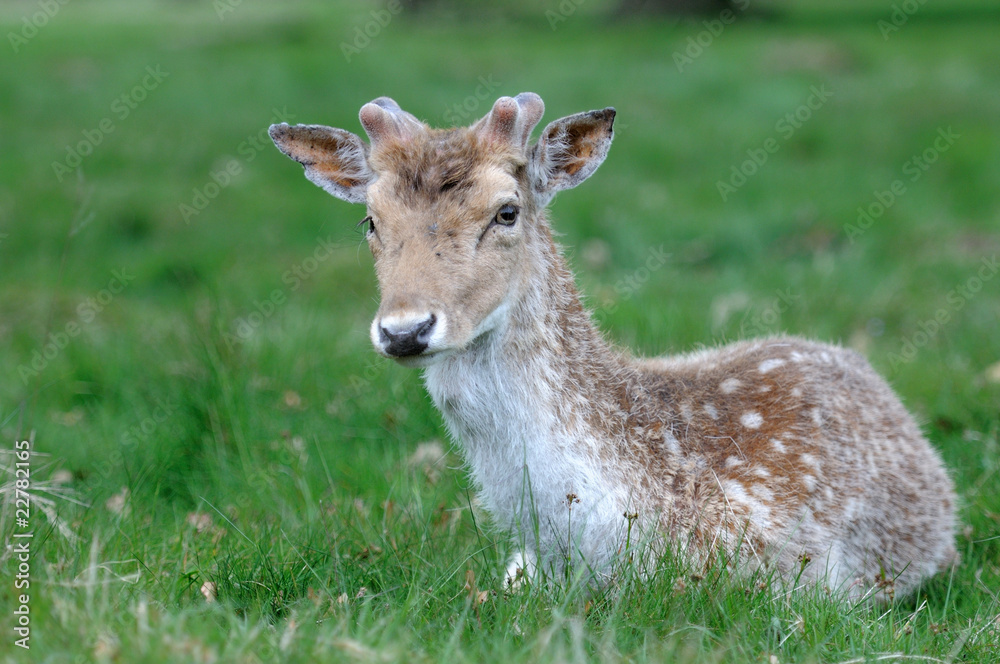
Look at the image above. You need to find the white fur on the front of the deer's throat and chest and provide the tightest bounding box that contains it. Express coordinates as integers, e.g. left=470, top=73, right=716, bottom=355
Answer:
left=424, top=349, right=628, bottom=569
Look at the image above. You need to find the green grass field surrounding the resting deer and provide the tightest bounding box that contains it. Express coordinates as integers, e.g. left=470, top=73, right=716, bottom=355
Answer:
left=0, top=0, right=1000, bottom=663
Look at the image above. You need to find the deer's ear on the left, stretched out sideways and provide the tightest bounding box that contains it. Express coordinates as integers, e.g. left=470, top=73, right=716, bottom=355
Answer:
left=268, top=122, right=375, bottom=203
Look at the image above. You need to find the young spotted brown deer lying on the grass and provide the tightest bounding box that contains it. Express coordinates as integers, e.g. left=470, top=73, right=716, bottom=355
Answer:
left=270, top=93, right=956, bottom=597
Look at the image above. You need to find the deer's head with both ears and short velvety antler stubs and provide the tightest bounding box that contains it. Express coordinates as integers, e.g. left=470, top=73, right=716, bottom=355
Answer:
left=270, top=92, right=615, bottom=366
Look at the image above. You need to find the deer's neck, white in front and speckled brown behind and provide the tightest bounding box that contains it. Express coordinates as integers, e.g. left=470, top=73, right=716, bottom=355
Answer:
left=424, top=230, right=623, bottom=519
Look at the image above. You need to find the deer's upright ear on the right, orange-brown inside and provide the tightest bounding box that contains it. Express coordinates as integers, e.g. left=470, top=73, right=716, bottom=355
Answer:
left=530, top=108, right=615, bottom=198
